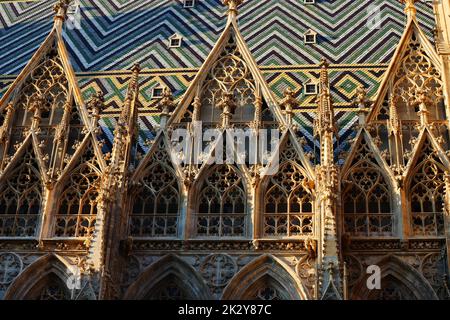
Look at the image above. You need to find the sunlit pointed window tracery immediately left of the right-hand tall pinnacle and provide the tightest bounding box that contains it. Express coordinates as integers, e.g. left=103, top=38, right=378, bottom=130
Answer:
left=263, top=141, right=314, bottom=237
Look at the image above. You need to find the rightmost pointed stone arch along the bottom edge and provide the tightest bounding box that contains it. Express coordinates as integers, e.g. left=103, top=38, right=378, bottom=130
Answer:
left=352, top=255, right=438, bottom=300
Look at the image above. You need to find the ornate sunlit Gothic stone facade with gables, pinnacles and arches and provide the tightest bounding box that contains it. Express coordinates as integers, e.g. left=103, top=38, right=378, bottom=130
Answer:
left=0, top=0, right=450, bottom=300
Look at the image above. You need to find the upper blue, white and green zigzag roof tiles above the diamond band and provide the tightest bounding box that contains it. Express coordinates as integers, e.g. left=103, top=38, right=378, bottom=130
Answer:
left=0, top=0, right=434, bottom=74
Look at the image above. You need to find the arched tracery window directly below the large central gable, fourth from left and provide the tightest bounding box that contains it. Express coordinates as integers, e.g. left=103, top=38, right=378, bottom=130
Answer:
left=195, top=165, right=247, bottom=237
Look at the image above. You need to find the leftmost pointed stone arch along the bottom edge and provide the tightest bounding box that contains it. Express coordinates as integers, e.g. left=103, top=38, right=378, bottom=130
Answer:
left=4, top=254, right=73, bottom=300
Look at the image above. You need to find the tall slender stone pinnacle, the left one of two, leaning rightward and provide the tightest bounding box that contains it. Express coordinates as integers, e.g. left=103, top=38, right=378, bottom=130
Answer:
left=88, top=64, right=140, bottom=299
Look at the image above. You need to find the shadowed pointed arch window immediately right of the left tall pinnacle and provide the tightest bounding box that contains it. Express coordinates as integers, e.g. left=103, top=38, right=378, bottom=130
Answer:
left=129, top=158, right=181, bottom=238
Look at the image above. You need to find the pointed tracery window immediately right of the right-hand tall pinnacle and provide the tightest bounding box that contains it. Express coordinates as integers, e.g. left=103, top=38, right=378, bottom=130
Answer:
left=341, top=129, right=394, bottom=237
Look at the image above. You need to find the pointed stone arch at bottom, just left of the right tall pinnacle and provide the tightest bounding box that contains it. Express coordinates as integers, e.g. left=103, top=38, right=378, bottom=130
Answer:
left=222, top=254, right=307, bottom=300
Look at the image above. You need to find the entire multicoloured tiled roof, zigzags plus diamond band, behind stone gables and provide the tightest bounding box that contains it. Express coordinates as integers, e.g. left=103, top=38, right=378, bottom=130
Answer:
left=0, top=0, right=435, bottom=159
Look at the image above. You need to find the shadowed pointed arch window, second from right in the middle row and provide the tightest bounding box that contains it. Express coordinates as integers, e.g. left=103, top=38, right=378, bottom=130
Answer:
left=342, top=139, right=394, bottom=237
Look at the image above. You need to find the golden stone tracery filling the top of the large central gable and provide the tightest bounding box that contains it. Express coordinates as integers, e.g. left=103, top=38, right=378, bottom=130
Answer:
left=201, top=34, right=256, bottom=123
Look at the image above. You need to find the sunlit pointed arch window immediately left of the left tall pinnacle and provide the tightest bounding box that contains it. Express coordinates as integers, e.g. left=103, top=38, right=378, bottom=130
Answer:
left=54, top=155, right=100, bottom=238
